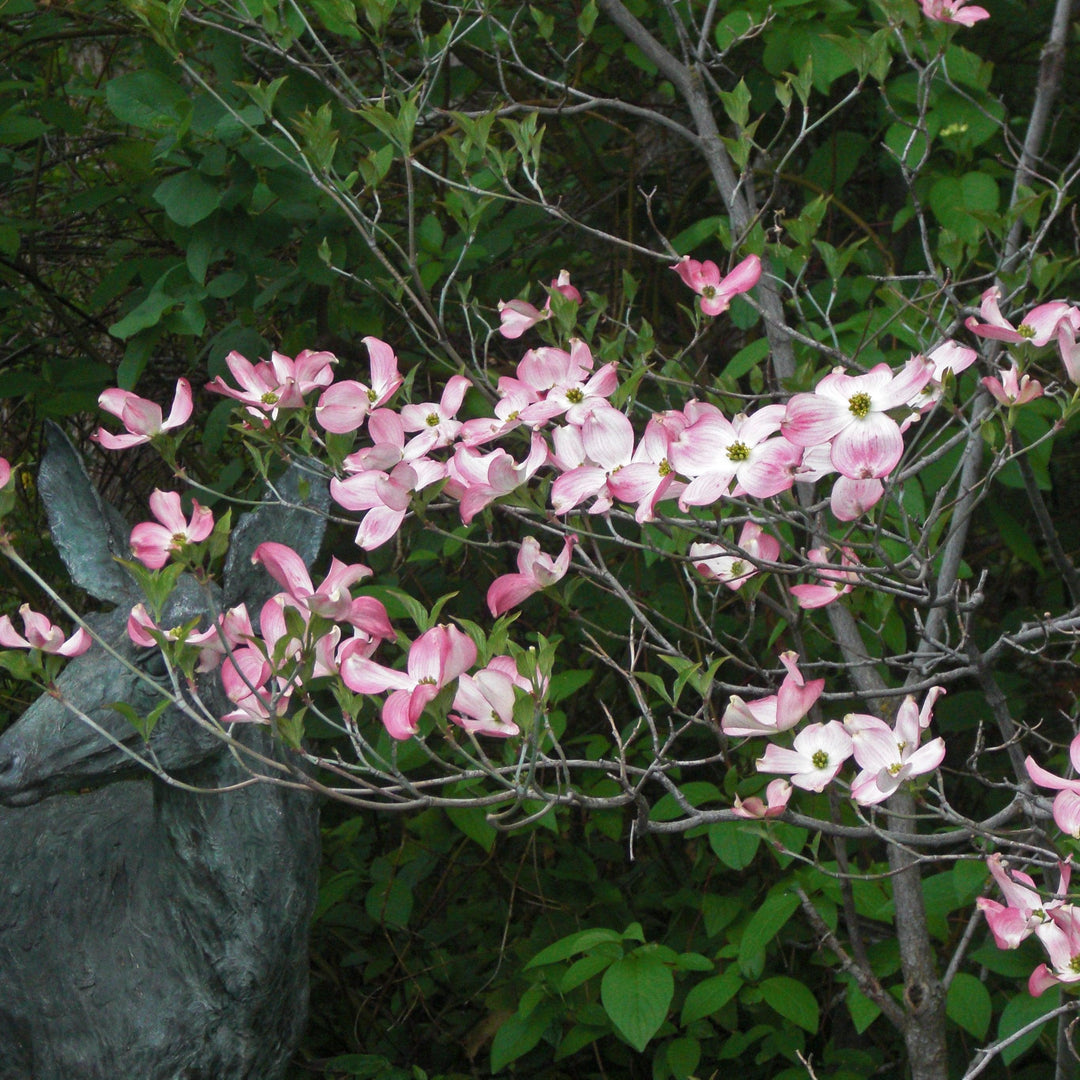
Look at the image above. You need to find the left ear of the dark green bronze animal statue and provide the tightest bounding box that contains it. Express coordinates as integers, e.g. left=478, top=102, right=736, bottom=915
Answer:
left=38, top=422, right=138, bottom=605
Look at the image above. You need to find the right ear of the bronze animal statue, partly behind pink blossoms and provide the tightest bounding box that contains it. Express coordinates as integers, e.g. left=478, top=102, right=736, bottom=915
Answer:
left=224, top=460, right=329, bottom=613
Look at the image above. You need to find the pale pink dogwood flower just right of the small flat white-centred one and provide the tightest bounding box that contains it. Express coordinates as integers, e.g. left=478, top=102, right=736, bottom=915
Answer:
left=843, top=687, right=945, bottom=806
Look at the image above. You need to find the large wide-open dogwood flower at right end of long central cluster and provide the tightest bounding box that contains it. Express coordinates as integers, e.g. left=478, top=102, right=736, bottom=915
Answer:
left=780, top=356, right=934, bottom=480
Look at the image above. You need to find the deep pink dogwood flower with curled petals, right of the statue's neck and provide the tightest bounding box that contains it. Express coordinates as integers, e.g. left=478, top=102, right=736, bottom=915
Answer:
left=341, top=624, right=476, bottom=739
